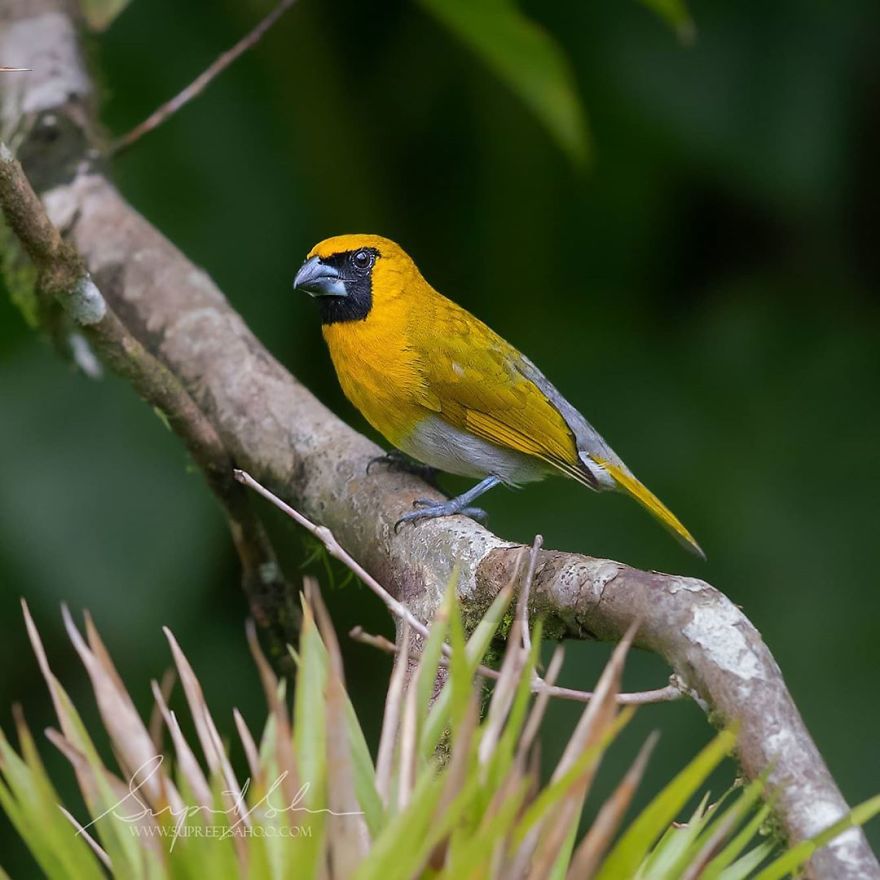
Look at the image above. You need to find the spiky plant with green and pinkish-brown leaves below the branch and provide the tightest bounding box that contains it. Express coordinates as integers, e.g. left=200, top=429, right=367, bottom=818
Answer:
left=0, top=582, right=880, bottom=880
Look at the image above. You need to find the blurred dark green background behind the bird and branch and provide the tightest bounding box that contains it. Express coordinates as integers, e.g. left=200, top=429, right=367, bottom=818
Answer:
left=0, top=0, right=880, bottom=876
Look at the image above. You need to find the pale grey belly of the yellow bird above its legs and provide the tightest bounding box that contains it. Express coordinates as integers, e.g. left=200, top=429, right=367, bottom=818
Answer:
left=397, top=415, right=548, bottom=485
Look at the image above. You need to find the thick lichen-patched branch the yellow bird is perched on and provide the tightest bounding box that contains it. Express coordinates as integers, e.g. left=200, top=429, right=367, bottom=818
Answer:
left=0, top=0, right=880, bottom=880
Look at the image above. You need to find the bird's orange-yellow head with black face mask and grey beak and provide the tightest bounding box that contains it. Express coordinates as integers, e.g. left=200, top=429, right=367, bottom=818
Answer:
left=293, top=235, right=421, bottom=324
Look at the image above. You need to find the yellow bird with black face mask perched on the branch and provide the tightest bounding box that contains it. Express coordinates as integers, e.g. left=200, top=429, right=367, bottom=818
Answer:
left=293, top=235, right=705, bottom=558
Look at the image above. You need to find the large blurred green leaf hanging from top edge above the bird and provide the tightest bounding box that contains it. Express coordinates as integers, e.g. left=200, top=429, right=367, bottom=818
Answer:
left=421, top=0, right=589, bottom=164
